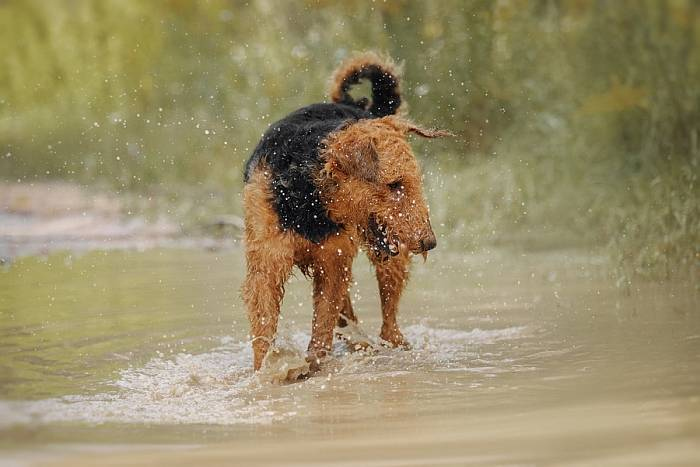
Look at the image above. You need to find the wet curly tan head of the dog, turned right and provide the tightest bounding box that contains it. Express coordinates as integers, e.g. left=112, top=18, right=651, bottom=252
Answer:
left=319, top=116, right=449, bottom=257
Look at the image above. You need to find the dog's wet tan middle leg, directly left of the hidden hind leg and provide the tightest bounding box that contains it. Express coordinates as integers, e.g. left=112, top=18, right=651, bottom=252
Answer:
left=308, top=252, right=352, bottom=368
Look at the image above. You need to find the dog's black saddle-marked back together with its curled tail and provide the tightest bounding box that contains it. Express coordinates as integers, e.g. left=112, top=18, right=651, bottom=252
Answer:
left=244, top=53, right=401, bottom=243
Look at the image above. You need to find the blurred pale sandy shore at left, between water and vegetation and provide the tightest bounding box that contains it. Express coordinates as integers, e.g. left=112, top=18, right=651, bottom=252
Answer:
left=0, top=182, right=237, bottom=263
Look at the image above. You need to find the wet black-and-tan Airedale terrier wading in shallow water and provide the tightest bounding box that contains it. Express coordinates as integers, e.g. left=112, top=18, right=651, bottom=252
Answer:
left=242, top=53, right=449, bottom=371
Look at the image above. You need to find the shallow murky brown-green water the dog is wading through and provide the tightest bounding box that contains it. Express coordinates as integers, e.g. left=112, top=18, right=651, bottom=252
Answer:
left=0, top=250, right=700, bottom=466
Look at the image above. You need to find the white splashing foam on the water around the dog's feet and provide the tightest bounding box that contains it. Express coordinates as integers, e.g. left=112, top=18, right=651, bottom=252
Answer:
left=0, top=324, right=527, bottom=428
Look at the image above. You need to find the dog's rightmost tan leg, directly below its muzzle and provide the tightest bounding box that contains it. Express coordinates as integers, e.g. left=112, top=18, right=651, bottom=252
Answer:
left=370, top=251, right=411, bottom=349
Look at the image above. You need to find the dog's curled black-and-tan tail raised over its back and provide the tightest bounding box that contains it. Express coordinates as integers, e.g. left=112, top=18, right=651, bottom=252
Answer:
left=330, top=52, right=401, bottom=117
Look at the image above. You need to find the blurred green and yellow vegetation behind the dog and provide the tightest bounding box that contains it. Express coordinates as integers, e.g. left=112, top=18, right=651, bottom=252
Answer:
left=0, top=0, right=700, bottom=284
